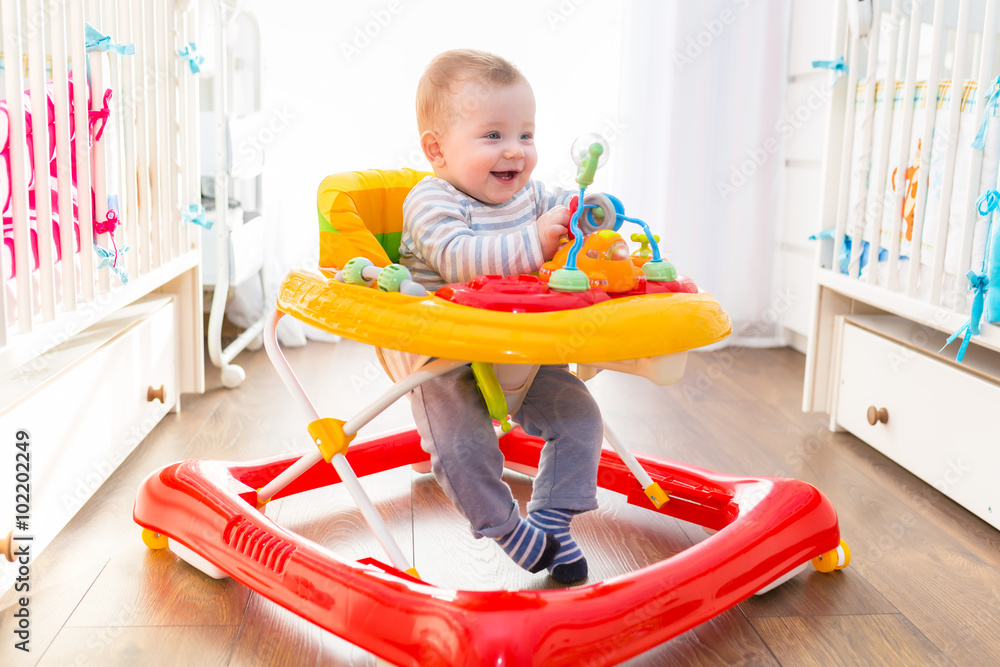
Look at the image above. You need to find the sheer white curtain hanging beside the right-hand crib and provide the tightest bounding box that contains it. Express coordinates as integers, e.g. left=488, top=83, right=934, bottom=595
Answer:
left=612, top=0, right=790, bottom=346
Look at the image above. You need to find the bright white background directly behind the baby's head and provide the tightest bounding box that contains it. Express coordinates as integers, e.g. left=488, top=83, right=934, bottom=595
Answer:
left=241, top=0, right=621, bottom=272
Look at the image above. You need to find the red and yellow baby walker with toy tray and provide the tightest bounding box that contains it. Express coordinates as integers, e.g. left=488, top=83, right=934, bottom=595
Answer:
left=134, top=137, right=850, bottom=665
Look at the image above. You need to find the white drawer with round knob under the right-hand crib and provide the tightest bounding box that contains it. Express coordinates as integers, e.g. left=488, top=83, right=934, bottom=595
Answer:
left=834, top=320, right=1000, bottom=528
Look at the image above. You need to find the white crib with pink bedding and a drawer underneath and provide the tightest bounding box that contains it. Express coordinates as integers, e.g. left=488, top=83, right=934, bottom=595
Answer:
left=0, top=0, right=204, bottom=572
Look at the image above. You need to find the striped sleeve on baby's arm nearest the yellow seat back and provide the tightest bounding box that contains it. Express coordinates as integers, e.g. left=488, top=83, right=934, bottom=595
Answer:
left=403, top=186, right=545, bottom=283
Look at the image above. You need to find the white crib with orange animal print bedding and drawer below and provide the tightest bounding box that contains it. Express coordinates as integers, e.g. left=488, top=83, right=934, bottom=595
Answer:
left=803, top=0, right=1000, bottom=527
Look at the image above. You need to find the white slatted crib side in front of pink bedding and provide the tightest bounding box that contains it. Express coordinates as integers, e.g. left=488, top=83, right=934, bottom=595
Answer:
left=0, top=0, right=200, bottom=371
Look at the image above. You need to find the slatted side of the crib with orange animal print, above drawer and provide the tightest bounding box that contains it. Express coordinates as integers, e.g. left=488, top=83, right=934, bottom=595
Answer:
left=818, top=0, right=1000, bottom=349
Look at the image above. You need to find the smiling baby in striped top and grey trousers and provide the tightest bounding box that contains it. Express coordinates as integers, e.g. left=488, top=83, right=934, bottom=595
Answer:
left=400, top=49, right=603, bottom=583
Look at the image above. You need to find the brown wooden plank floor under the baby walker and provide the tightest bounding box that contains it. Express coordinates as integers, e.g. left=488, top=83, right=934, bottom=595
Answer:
left=0, top=341, right=1000, bottom=666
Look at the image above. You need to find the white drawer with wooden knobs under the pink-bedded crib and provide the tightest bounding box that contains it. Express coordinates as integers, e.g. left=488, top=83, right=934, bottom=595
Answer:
left=0, top=297, right=178, bottom=556
